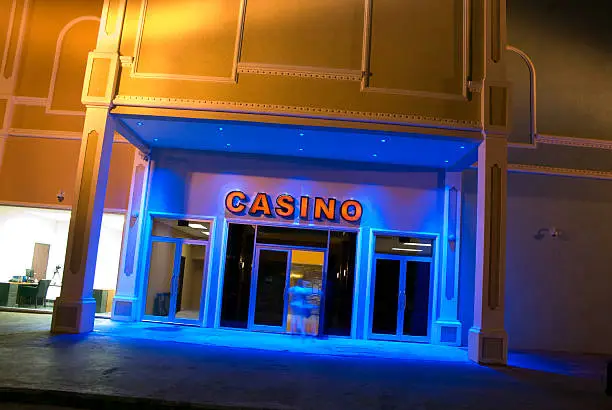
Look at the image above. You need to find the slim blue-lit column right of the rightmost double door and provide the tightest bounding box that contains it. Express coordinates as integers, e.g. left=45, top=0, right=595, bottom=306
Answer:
left=432, top=172, right=461, bottom=346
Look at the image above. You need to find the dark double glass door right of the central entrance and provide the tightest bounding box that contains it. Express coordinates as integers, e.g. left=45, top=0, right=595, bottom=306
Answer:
left=370, top=255, right=431, bottom=341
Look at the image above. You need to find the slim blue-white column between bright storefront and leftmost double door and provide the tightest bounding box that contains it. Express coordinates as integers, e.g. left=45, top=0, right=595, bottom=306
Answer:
left=111, top=150, right=151, bottom=321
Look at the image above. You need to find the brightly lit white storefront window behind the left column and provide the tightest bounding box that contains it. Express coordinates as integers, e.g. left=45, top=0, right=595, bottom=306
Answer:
left=0, top=206, right=125, bottom=313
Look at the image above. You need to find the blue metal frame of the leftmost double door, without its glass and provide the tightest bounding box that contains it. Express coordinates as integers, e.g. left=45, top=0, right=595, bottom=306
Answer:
left=142, top=235, right=210, bottom=325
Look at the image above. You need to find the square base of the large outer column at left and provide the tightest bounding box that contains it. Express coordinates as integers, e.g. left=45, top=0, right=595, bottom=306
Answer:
left=51, top=297, right=96, bottom=333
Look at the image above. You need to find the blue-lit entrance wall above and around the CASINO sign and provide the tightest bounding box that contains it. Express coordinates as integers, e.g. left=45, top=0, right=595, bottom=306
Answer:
left=148, top=151, right=444, bottom=336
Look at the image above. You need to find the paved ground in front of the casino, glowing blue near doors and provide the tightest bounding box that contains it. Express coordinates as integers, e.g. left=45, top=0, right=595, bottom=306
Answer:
left=0, top=312, right=612, bottom=410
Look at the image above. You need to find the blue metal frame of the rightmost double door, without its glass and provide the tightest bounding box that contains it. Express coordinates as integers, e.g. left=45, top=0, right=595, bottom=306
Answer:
left=368, top=253, right=433, bottom=342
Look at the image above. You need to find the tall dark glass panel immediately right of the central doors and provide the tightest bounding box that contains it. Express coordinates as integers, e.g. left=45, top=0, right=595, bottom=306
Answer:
left=323, top=231, right=357, bottom=336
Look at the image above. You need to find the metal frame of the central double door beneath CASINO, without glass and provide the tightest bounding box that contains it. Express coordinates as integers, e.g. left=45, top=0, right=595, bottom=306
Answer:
left=247, top=243, right=328, bottom=336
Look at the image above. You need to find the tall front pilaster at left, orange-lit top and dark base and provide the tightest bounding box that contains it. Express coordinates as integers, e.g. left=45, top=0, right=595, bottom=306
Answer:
left=51, top=0, right=126, bottom=333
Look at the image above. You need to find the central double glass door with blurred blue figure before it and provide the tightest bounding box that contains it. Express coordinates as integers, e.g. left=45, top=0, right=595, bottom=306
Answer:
left=249, top=246, right=327, bottom=335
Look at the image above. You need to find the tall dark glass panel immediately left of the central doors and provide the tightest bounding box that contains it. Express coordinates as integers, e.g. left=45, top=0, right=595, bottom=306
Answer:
left=220, top=224, right=255, bottom=329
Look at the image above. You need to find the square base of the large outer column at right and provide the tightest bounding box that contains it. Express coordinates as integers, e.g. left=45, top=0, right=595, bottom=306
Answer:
left=468, top=327, right=508, bottom=366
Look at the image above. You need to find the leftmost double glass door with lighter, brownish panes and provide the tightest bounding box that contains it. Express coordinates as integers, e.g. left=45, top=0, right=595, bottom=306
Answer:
left=144, top=236, right=207, bottom=324
